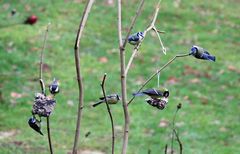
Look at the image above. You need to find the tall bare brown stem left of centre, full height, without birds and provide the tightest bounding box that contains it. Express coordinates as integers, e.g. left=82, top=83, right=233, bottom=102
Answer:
left=72, top=0, right=94, bottom=154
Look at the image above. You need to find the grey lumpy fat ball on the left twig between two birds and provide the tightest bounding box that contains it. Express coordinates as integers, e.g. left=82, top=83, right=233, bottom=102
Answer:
left=32, top=93, right=56, bottom=117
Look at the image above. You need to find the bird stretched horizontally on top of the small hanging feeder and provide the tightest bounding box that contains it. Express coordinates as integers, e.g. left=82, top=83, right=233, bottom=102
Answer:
left=133, top=88, right=169, bottom=99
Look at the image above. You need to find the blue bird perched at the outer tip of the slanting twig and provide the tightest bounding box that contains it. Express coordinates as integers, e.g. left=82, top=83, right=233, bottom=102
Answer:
left=190, top=45, right=216, bottom=62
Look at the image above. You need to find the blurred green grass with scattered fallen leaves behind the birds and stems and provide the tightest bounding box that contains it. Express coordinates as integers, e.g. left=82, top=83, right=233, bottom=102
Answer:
left=0, top=0, right=240, bottom=154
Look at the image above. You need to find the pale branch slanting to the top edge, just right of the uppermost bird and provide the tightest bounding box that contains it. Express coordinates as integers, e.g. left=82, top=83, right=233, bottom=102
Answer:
left=125, top=0, right=161, bottom=75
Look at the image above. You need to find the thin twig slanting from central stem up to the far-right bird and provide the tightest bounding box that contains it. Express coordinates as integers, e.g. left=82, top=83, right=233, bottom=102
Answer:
left=128, top=54, right=190, bottom=105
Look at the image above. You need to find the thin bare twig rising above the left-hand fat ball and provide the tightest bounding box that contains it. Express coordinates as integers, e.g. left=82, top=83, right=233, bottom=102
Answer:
left=39, top=23, right=50, bottom=95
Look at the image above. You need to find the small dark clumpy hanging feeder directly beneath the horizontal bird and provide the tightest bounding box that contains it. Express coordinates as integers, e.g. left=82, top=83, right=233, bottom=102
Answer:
left=146, top=97, right=168, bottom=110
